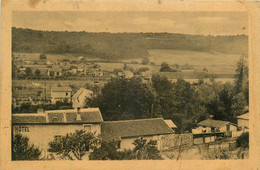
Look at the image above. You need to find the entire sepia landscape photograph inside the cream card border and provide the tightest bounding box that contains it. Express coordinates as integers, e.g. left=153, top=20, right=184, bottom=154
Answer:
left=10, top=10, right=250, bottom=161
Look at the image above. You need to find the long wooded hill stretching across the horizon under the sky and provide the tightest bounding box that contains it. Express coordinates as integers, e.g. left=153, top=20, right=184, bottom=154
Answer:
left=12, top=28, right=248, bottom=59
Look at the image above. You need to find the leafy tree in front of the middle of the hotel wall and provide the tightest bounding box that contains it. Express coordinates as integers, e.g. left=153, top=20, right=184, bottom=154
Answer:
left=48, top=130, right=99, bottom=160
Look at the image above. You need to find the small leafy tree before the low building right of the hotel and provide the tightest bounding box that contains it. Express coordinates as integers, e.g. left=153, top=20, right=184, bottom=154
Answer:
left=133, top=137, right=162, bottom=160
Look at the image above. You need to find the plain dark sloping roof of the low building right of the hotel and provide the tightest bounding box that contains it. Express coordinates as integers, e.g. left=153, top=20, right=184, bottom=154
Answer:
left=101, top=118, right=173, bottom=141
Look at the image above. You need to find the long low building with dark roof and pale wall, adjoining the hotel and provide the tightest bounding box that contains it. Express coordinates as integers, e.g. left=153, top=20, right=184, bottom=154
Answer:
left=101, top=118, right=174, bottom=150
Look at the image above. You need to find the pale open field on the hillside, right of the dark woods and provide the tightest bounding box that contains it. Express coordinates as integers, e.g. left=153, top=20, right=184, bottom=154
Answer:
left=149, top=50, right=240, bottom=74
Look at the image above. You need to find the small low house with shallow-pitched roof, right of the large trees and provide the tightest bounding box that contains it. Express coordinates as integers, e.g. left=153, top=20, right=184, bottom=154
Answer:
left=192, top=119, right=237, bottom=134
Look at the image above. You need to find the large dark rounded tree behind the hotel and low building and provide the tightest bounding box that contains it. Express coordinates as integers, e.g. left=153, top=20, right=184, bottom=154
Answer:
left=85, top=77, right=155, bottom=120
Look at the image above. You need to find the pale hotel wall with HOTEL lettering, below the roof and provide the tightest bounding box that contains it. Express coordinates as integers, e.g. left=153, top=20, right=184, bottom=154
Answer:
left=13, top=124, right=101, bottom=156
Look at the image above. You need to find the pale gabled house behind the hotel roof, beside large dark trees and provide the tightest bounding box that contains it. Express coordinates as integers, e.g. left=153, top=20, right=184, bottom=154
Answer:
left=72, top=88, right=93, bottom=108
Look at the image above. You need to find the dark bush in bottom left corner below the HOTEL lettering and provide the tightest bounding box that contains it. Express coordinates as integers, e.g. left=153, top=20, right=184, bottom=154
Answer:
left=12, top=134, right=41, bottom=160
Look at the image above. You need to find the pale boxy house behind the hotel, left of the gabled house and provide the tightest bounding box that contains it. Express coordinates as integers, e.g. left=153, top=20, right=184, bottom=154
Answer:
left=51, top=87, right=72, bottom=103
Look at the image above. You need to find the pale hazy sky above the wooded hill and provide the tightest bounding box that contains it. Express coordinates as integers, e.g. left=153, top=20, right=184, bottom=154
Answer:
left=12, top=11, right=248, bottom=35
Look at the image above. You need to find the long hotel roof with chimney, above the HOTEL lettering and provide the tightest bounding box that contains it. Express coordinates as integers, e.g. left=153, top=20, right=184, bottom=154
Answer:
left=12, top=108, right=103, bottom=124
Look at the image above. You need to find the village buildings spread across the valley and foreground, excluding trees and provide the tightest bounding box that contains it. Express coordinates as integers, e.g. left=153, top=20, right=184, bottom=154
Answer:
left=12, top=52, right=249, bottom=159
